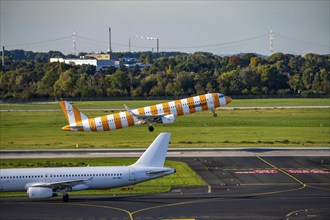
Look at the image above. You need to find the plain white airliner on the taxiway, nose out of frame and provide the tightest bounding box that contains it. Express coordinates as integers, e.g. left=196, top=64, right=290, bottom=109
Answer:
left=0, top=133, right=175, bottom=202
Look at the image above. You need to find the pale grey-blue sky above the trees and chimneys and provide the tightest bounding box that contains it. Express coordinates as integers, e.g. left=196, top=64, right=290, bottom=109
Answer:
left=0, top=0, right=330, bottom=55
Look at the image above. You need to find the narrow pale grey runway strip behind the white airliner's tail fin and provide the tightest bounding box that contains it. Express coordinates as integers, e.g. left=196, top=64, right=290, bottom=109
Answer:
left=0, top=147, right=330, bottom=159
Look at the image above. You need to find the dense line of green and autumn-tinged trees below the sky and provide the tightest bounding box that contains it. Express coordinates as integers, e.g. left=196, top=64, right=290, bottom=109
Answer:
left=0, top=51, right=330, bottom=100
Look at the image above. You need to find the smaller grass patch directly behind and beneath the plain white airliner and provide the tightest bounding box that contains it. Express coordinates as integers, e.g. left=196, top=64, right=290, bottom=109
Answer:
left=0, top=158, right=205, bottom=196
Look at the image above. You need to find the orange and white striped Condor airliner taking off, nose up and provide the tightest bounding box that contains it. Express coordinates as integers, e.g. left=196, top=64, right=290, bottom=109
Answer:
left=60, top=93, right=231, bottom=132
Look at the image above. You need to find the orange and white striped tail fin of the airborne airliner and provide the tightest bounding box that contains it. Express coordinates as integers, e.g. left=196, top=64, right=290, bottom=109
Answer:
left=60, top=101, right=88, bottom=125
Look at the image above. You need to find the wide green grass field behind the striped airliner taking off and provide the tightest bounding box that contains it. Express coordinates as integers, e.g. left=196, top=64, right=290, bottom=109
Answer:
left=0, top=99, right=330, bottom=150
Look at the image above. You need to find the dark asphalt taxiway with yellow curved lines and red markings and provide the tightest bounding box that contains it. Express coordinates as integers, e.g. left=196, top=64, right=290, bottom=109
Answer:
left=0, top=155, right=330, bottom=220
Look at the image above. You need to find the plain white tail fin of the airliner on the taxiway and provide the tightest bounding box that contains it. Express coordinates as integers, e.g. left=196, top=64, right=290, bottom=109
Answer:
left=133, top=133, right=171, bottom=167
